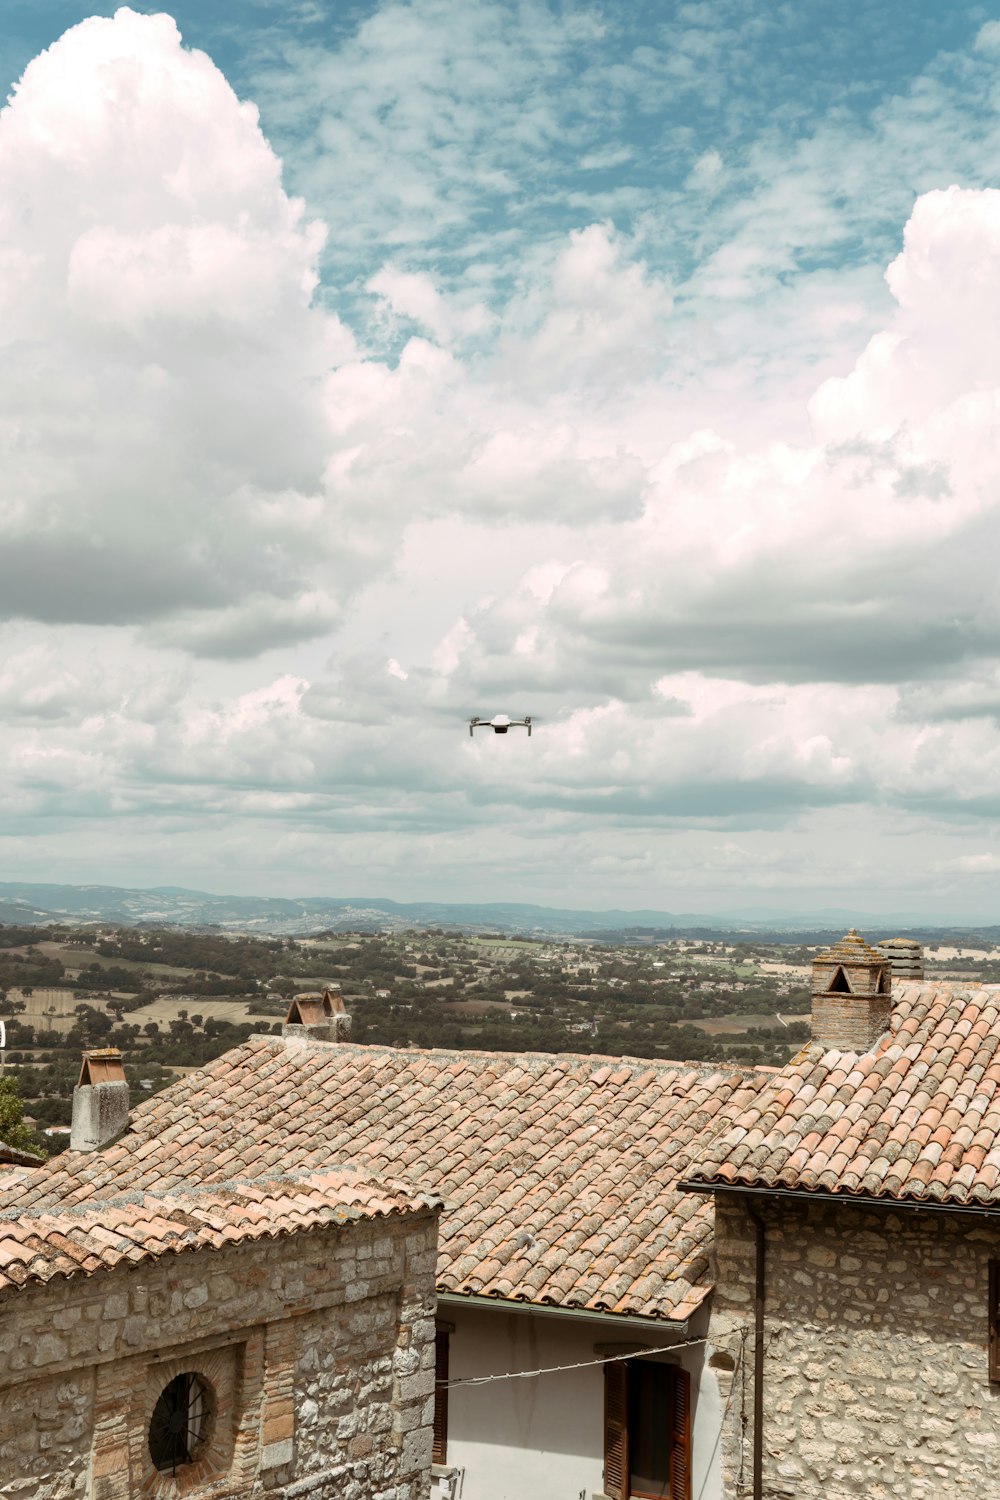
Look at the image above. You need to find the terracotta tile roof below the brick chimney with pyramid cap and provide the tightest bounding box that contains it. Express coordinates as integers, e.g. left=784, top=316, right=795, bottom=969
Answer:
left=688, top=984, right=1000, bottom=1205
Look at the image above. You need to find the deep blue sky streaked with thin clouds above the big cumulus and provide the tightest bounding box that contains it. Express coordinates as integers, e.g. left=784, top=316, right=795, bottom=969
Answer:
left=3, top=0, right=996, bottom=293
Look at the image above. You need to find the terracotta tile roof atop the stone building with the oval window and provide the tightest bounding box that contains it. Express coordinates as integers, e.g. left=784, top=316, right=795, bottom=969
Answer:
left=0, top=1167, right=439, bottom=1292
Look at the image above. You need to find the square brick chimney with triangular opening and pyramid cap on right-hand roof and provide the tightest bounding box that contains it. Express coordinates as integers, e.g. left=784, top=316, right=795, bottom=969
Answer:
left=813, top=929, right=892, bottom=1052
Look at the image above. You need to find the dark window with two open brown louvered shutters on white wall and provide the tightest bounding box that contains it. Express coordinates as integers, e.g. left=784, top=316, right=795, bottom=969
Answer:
left=604, top=1359, right=691, bottom=1500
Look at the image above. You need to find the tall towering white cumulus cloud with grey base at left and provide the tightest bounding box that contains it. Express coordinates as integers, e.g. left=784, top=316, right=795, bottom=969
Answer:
left=0, top=9, right=354, bottom=650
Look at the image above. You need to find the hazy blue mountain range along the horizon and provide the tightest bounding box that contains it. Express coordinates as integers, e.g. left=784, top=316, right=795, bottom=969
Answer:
left=0, top=881, right=1000, bottom=938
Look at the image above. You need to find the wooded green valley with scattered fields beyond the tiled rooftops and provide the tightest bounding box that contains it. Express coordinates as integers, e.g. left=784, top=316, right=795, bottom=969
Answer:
left=7, top=887, right=1000, bottom=1151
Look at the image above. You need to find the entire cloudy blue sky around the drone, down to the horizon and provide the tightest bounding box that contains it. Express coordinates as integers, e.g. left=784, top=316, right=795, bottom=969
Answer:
left=0, top=0, right=1000, bottom=921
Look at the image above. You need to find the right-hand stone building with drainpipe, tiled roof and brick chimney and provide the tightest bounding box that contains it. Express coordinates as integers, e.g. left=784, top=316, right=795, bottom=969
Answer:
left=684, top=933, right=1000, bottom=1500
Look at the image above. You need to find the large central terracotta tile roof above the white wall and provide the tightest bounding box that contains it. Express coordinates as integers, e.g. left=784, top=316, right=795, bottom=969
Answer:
left=7, top=1037, right=762, bottom=1319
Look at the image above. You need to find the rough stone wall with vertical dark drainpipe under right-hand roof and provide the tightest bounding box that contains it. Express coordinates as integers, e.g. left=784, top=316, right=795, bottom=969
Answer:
left=709, top=1194, right=1000, bottom=1500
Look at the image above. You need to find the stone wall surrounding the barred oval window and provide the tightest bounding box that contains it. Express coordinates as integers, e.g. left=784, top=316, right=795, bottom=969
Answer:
left=0, top=1214, right=436, bottom=1500
